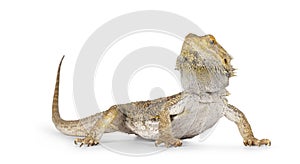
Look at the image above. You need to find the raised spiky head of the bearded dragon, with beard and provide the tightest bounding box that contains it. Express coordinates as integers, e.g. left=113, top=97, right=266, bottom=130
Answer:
left=176, top=34, right=234, bottom=92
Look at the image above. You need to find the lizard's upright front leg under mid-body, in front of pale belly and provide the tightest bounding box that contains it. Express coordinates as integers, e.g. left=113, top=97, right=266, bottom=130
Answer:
left=155, top=109, right=182, bottom=147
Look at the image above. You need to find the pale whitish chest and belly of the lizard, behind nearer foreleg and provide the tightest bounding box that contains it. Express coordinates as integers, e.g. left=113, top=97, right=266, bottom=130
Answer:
left=126, top=95, right=224, bottom=140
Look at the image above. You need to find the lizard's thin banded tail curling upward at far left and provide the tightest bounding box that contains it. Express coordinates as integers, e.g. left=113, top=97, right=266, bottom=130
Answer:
left=52, top=56, right=86, bottom=136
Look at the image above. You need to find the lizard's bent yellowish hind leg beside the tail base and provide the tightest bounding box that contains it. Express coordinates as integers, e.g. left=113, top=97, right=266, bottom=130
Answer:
left=74, top=105, right=119, bottom=147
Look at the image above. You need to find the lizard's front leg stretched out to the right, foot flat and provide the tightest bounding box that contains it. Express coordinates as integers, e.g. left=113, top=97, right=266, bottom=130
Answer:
left=225, top=104, right=271, bottom=146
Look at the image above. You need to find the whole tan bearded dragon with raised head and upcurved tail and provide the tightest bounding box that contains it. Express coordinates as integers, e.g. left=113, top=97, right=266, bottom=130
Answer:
left=52, top=34, right=271, bottom=147
